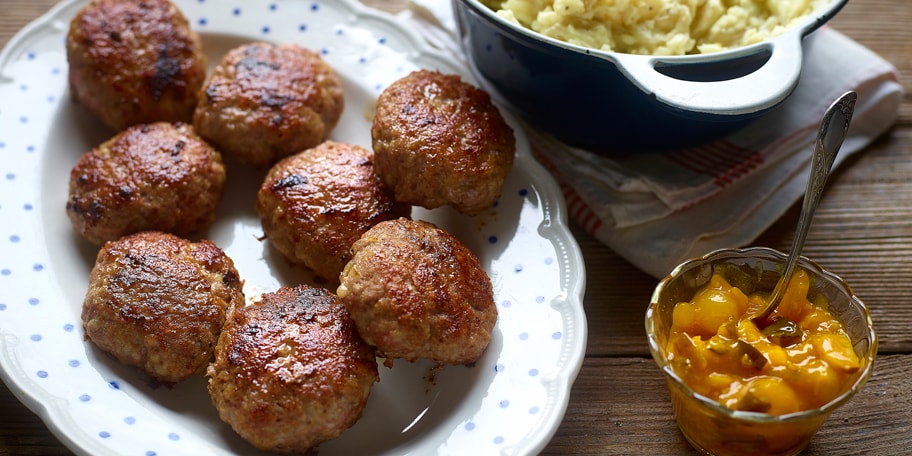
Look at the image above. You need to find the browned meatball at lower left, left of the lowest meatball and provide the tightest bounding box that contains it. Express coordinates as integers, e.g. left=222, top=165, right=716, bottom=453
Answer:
left=82, top=231, right=244, bottom=383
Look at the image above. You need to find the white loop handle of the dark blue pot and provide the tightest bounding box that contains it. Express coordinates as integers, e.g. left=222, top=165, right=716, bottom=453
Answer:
left=617, top=34, right=802, bottom=115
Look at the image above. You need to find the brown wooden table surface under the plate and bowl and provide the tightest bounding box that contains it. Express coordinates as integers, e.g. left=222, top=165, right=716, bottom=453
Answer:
left=0, top=0, right=912, bottom=455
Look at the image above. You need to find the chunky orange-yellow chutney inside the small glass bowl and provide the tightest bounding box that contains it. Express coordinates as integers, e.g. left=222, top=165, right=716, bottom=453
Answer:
left=666, top=269, right=861, bottom=415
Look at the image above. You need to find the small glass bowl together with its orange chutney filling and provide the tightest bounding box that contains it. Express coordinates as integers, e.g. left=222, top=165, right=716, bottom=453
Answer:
left=645, top=247, right=877, bottom=456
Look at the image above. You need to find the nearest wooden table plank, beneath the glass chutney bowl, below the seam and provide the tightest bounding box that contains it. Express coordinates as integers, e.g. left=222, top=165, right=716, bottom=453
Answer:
left=542, top=355, right=912, bottom=456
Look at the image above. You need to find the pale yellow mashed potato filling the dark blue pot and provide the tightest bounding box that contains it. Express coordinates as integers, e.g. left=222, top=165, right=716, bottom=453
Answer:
left=482, top=0, right=831, bottom=55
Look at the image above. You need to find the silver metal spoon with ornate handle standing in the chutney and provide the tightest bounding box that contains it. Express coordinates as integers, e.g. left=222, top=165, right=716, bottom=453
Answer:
left=751, top=91, right=858, bottom=327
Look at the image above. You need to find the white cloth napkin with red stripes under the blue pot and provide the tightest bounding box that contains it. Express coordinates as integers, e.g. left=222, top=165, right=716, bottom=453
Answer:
left=400, top=0, right=903, bottom=277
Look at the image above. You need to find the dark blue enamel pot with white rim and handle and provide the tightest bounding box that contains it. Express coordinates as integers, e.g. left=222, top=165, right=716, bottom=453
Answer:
left=453, top=0, right=848, bottom=153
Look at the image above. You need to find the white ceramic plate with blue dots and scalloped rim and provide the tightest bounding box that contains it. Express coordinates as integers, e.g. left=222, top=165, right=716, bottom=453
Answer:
left=0, top=0, right=586, bottom=456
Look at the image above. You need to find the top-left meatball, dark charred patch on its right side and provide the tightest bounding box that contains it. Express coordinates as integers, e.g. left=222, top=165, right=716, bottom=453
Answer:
left=66, top=0, right=206, bottom=131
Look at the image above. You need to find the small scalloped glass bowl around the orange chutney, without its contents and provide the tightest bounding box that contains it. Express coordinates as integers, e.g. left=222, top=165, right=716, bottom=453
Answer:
left=646, top=247, right=877, bottom=456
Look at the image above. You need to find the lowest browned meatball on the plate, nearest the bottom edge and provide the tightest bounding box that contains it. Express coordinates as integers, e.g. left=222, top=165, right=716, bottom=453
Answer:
left=207, top=285, right=380, bottom=453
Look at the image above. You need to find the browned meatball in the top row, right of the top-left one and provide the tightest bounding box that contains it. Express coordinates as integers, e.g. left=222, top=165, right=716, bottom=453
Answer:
left=193, top=42, right=345, bottom=167
